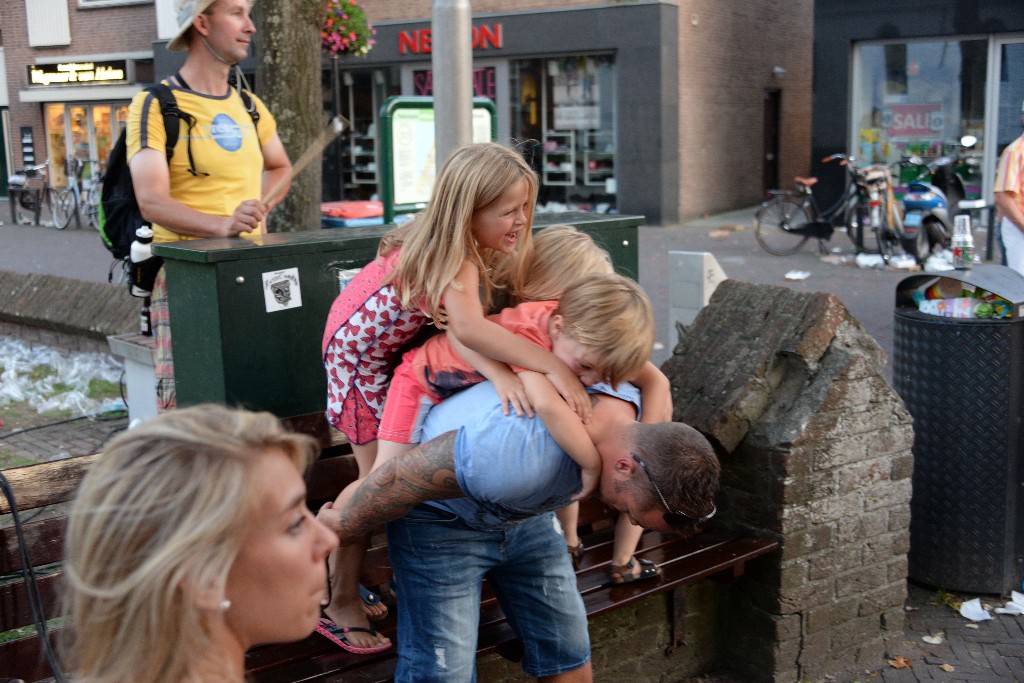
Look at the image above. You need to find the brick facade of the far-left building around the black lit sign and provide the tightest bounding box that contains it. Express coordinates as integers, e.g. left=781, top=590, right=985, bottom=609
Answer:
left=0, top=0, right=157, bottom=166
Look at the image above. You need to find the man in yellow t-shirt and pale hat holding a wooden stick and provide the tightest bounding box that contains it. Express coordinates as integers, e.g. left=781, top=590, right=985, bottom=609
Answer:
left=127, top=0, right=292, bottom=410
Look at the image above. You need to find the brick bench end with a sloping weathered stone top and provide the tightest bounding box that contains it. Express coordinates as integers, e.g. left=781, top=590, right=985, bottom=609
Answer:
left=663, top=281, right=913, bottom=682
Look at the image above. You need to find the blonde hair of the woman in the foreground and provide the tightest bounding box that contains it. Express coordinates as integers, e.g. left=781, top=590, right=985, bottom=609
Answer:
left=63, top=405, right=315, bottom=683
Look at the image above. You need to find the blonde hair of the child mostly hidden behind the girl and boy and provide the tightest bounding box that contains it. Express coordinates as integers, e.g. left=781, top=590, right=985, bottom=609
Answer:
left=518, top=225, right=615, bottom=302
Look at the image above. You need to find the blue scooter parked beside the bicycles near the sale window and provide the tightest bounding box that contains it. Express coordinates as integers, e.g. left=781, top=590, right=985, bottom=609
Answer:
left=901, top=135, right=978, bottom=263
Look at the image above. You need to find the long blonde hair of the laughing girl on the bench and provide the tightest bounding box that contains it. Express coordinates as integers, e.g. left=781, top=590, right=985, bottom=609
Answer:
left=380, top=142, right=538, bottom=328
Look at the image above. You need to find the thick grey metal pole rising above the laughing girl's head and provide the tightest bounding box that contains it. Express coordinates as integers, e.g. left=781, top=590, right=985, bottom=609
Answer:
left=431, top=0, right=473, bottom=171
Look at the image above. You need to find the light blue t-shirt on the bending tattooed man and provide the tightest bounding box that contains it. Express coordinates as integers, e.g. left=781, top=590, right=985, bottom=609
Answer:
left=423, top=382, right=640, bottom=530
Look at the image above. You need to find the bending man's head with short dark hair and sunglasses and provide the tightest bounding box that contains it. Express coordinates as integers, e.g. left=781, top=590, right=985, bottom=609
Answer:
left=601, top=422, right=721, bottom=533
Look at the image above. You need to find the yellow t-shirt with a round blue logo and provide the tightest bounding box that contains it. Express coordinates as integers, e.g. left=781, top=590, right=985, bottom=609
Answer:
left=127, top=81, right=278, bottom=242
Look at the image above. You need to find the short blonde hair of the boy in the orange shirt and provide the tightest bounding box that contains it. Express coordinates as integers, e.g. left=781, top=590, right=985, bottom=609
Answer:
left=555, top=273, right=655, bottom=386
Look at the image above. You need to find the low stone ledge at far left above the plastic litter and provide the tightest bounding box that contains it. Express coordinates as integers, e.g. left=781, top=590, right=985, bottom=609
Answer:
left=0, top=270, right=141, bottom=346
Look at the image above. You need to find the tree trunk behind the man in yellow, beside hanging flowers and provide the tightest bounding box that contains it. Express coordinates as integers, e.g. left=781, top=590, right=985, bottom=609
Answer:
left=253, top=0, right=327, bottom=232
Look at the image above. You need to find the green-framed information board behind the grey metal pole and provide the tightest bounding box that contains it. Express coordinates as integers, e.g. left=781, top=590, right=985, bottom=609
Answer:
left=380, top=96, right=498, bottom=223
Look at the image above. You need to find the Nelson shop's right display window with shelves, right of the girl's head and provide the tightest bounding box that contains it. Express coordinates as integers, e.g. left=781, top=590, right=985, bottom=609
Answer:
left=510, top=55, right=616, bottom=213
